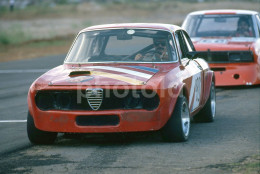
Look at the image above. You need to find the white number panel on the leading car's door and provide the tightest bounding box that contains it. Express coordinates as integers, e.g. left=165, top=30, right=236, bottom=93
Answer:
left=189, top=73, right=201, bottom=111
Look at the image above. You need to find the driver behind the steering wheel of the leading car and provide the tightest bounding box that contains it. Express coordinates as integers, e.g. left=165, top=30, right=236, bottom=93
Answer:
left=135, top=38, right=168, bottom=62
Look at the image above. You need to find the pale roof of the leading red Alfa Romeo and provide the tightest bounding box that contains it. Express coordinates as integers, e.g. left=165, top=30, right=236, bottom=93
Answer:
left=80, top=23, right=183, bottom=33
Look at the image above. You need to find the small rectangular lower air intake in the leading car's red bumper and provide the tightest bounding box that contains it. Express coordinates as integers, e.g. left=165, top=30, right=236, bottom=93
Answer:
left=76, top=115, right=119, bottom=126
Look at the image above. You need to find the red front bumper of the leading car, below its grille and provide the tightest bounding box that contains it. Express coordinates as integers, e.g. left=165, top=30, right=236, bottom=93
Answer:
left=31, top=110, right=165, bottom=133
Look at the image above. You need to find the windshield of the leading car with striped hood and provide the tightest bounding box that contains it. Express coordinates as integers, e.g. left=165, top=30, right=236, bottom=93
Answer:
left=65, top=29, right=177, bottom=63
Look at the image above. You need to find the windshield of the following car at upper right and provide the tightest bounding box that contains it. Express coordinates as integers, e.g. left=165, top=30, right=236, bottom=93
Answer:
left=183, top=14, right=256, bottom=37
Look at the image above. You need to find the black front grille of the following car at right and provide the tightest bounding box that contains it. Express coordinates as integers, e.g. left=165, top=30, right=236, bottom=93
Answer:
left=197, top=51, right=254, bottom=63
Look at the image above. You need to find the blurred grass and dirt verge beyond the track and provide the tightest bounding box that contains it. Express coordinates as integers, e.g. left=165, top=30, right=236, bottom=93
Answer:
left=0, top=0, right=259, bottom=62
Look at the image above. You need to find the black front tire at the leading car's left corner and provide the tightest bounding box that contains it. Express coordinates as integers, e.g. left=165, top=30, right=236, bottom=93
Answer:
left=27, top=112, right=58, bottom=144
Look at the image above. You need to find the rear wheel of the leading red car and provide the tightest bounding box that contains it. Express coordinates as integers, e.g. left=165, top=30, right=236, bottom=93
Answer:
left=194, top=81, right=216, bottom=122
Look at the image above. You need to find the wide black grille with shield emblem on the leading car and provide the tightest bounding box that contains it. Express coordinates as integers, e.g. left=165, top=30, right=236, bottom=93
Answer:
left=35, top=90, right=159, bottom=111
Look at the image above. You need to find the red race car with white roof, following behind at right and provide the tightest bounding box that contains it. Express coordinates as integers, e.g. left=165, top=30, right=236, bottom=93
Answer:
left=182, top=10, right=260, bottom=86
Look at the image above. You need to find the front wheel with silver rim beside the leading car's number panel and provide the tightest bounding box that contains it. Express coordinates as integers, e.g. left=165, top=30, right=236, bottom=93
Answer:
left=161, top=96, right=190, bottom=142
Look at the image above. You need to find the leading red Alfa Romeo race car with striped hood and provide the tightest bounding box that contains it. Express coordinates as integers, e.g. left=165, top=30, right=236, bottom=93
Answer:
left=27, top=24, right=216, bottom=144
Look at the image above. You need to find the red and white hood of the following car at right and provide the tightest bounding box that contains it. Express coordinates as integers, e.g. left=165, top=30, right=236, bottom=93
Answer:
left=192, top=37, right=256, bottom=51
